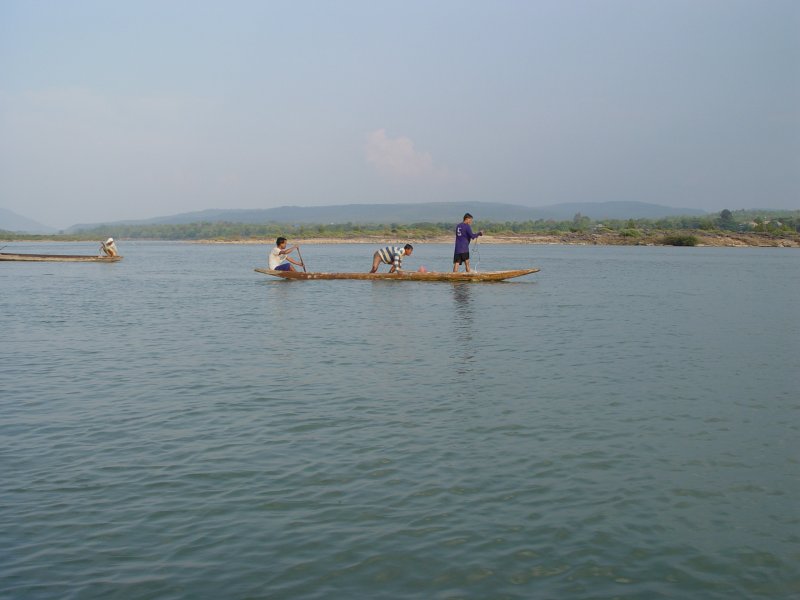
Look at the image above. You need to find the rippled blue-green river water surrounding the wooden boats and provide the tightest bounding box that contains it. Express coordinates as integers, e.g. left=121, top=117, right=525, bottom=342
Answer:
left=0, top=242, right=800, bottom=600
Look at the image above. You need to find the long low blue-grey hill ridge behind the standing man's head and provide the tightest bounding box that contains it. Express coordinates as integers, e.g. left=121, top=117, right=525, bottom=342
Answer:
left=66, top=202, right=705, bottom=233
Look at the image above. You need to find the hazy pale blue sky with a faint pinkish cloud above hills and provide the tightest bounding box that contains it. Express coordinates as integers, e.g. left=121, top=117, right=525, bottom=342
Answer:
left=0, top=0, right=800, bottom=228
